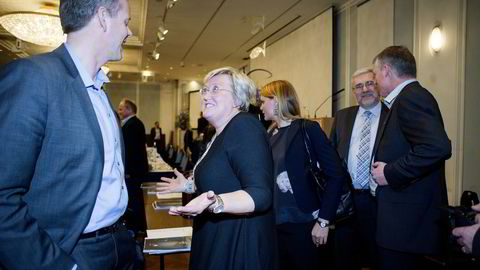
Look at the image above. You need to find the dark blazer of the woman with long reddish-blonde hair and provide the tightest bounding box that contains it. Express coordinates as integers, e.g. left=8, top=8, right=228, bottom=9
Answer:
left=285, top=120, right=346, bottom=220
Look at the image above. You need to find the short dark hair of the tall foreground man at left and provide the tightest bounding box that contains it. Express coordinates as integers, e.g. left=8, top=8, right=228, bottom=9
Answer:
left=59, top=0, right=120, bottom=34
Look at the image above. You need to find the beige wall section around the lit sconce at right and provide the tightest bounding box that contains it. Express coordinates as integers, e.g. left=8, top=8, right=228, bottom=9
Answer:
left=414, top=0, right=464, bottom=202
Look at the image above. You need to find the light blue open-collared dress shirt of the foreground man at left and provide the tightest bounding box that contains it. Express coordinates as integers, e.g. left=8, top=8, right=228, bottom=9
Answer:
left=65, top=43, right=128, bottom=233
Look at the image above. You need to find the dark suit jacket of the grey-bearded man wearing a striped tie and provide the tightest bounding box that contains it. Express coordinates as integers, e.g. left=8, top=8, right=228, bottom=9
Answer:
left=330, top=103, right=388, bottom=170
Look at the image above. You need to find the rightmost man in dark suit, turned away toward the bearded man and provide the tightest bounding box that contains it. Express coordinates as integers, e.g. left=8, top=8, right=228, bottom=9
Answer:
left=372, top=46, right=452, bottom=270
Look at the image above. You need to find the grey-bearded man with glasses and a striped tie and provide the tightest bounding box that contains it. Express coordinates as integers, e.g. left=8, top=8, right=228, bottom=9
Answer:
left=330, top=68, right=388, bottom=269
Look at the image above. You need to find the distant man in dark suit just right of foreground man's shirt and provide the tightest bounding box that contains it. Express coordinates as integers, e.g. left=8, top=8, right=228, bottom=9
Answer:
left=117, top=98, right=148, bottom=233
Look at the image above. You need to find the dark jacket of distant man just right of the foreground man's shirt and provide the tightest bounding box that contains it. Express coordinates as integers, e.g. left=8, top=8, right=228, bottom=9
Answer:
left=122, top=116, right=148, bottom=178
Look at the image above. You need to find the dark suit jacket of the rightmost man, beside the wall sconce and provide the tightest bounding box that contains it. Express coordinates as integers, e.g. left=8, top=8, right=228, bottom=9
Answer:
left=374, top=82, right=452, bottom=253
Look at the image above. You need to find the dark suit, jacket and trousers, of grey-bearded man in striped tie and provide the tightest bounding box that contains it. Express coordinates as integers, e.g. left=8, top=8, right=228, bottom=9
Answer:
left=330, top=103, right=388, bottom=269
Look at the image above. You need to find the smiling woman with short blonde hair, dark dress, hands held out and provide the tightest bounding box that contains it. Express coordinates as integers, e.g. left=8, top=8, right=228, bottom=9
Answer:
left=160, top=67, right=276, bottom=270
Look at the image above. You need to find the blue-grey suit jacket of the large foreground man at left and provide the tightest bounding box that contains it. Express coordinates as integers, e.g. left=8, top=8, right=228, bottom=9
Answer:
left=0, top=45, right=123, bottom=269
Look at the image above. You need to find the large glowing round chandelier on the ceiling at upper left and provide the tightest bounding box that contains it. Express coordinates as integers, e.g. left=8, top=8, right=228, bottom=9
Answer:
left=0, top=7, right=66, bottom=47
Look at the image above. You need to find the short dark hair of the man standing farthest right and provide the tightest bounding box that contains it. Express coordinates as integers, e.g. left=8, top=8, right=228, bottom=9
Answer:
left=373, top=46, right=417, bottom=78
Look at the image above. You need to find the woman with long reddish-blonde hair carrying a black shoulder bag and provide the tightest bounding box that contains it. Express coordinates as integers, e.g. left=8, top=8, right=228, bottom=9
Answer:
left=260, top=80, right=349, bottom=269
